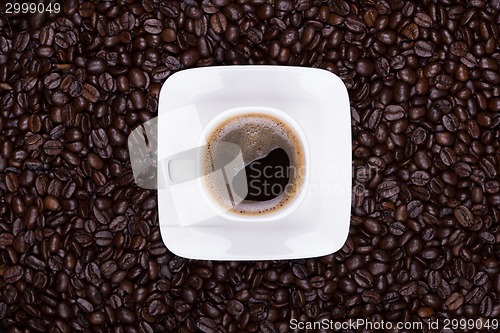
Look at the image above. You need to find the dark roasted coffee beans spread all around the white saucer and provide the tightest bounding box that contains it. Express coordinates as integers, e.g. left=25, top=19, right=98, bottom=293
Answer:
left=0, top=0, right=500, bottom=332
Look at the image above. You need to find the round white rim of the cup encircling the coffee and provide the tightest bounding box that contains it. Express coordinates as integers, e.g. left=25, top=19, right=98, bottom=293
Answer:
left=197, top=106, right=310, bottom=222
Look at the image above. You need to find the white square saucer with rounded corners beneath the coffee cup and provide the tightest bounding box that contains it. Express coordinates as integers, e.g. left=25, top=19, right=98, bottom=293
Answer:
left=158, top=66, right=352, bottom=260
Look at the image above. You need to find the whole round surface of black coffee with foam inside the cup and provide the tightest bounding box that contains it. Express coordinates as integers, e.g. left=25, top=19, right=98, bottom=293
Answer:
left=202, top=113, right=304, bottom=215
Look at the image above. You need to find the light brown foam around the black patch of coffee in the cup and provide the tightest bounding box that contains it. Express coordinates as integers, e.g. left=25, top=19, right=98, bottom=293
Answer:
left=202, top=113, right=304, bottom=215
